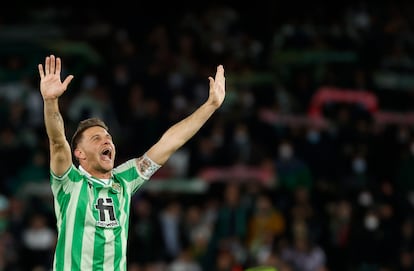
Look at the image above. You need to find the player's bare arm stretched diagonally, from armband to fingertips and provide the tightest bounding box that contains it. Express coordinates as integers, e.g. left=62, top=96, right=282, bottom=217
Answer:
left=143, top=65, right=226, bottom=165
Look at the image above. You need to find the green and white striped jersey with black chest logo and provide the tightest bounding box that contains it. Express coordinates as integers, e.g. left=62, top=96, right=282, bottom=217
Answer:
left=50, top=159, right=147, bottom=271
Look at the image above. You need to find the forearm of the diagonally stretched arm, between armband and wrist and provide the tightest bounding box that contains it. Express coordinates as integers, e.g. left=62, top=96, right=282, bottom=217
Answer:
left=147, top=103, right=217, bottom=165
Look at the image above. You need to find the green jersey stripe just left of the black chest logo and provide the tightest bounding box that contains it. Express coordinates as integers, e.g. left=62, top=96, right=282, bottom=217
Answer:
left=72, top=181, right=88, bottom=268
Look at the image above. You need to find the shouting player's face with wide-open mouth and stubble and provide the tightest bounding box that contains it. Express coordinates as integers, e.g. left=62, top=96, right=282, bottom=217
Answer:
left=79, top=126, right=115, bottom=172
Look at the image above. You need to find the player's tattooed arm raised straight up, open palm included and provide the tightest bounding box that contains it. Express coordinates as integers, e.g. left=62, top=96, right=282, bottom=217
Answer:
left=38, top=55, right=73, bottom=176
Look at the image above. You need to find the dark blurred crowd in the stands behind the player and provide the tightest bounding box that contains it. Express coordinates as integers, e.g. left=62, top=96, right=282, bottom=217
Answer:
left=0, top=1, right=414, bottom=271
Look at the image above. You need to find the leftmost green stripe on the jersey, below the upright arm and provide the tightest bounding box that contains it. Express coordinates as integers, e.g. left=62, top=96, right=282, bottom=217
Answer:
left=55, top=190, right=70, bottom=271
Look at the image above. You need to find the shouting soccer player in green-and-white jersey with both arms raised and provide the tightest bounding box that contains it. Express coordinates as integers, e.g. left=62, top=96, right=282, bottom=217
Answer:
left=38, top=54, right=225, bottom=271
